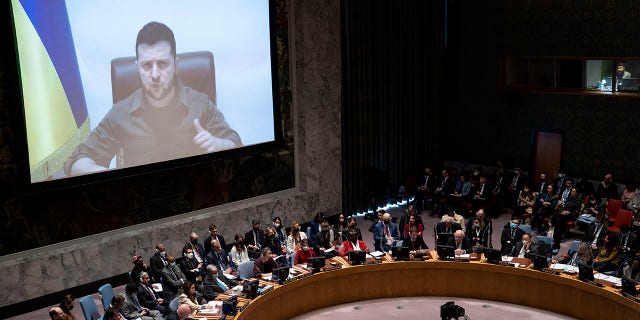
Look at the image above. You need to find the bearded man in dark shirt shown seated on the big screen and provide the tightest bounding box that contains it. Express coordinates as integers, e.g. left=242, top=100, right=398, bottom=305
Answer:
left=64, top=22, right=242, bottom=175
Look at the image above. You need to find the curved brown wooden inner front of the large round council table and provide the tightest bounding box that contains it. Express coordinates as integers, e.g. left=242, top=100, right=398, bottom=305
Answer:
left=236, top=261, right=640, bottom=320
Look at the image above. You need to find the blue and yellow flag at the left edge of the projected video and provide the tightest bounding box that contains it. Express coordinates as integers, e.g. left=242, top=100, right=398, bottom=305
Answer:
left=11, top=0, right=90, bottom=182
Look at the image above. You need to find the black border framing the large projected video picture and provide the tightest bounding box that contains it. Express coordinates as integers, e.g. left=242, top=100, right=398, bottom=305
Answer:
left=4, top=0, right=286, bottom=196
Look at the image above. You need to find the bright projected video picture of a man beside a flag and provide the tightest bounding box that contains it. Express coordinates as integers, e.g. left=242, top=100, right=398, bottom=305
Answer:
left=12, top=0, right=275, bottom=182
